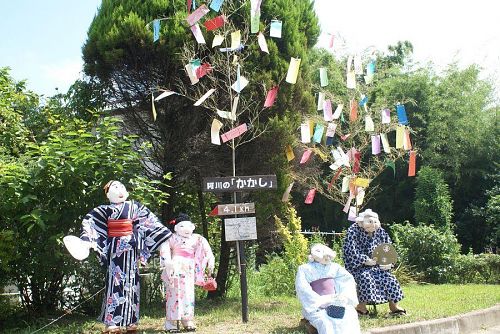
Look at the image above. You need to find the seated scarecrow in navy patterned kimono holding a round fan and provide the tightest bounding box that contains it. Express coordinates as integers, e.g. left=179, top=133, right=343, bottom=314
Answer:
left=343, top=209, right=406, bottom=316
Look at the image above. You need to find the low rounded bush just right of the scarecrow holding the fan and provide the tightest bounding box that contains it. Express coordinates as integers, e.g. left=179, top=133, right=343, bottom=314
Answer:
left=391, top=223, right=460, bottom=283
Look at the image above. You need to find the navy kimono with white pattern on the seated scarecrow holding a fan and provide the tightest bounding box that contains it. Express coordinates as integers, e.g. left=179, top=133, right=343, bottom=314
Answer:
left=343, top=223, right=403, bottom=304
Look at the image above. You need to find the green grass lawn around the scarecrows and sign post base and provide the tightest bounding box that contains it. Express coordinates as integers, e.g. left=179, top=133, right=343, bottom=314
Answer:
left=3, top=284, right=500, bottom=334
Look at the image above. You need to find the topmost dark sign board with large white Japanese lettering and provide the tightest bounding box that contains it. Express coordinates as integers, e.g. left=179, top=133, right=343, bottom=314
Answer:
left=203, top=175, right=278, bottom=192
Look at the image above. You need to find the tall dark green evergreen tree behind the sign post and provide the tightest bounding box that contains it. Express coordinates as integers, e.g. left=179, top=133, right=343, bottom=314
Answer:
left=83, top=0, right=319, bottom=298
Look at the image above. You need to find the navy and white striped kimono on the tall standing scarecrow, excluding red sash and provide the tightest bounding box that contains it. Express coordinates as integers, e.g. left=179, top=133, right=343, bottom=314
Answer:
left=80, top=201, right=172, bottom=327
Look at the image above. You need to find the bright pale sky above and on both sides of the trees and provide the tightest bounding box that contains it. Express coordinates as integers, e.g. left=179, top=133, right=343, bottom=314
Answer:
left=0, top=0, right=500, bottom=96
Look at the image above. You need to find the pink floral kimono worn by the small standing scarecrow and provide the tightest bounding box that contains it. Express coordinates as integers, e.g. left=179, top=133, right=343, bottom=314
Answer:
left=162, top=233, right=213, bottom=321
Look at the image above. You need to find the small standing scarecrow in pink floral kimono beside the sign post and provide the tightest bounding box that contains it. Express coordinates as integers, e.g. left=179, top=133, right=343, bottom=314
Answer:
left=160, top=213, right=215, bottom=332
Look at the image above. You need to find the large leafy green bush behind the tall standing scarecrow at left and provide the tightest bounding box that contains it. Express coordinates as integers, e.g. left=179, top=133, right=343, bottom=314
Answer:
left=0, top=110, right=170, bottom=314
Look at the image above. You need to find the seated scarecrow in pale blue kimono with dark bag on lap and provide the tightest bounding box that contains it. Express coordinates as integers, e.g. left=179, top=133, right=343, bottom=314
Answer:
left=295, top=244, right=361, bottom=334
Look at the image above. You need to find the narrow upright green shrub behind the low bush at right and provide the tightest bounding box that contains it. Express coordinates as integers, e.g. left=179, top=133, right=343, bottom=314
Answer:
left=414, top=167, right=453, bottom=229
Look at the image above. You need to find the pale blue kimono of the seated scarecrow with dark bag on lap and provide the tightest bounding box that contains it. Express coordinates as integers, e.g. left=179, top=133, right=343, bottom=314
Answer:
left=295, top=262, right=360, bottom=334
